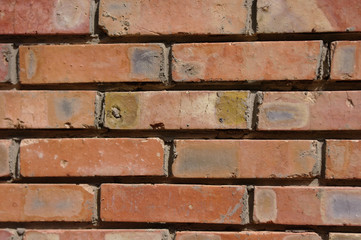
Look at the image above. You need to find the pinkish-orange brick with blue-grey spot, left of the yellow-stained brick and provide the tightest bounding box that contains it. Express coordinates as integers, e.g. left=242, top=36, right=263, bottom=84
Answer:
left=0, top=91, right=96, bottom=128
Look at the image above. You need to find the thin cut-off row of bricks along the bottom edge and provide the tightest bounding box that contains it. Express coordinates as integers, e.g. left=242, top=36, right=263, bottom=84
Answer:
left=0, top=229, right=361, bottom=240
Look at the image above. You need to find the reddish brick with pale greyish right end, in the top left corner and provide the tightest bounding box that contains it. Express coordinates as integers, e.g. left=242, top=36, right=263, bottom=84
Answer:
left=0, top=0, right=90, bottom=35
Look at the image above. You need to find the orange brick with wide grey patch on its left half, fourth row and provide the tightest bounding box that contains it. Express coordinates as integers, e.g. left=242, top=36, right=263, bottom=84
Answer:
left=172, top=140, right=321, bottom=178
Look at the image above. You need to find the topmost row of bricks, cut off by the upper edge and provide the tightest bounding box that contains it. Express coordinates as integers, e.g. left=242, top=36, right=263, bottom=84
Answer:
left=0, top=0, right=361, bottom=37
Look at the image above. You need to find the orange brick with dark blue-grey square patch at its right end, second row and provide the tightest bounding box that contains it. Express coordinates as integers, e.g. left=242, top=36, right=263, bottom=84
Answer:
left=19, top=44, right=168, bottom=84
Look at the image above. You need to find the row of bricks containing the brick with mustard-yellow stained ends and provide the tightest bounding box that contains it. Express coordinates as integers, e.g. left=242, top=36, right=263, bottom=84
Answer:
left=0, top=91, right=361, bottom=131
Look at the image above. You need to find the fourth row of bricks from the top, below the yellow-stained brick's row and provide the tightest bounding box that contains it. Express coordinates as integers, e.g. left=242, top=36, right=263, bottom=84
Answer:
left=0, top=138, right=361, bottom=179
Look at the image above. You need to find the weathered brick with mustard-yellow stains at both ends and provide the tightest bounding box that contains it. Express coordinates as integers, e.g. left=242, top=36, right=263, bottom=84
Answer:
left=105, top=91, right=252, bottom=129
